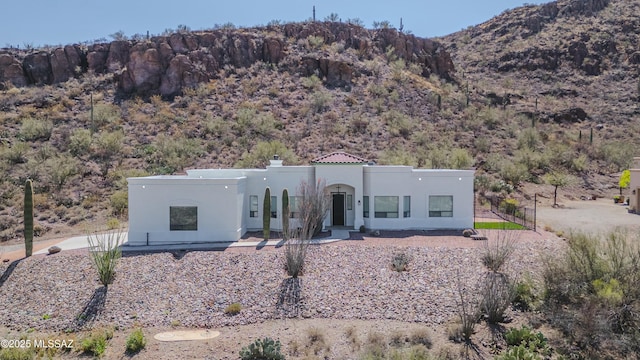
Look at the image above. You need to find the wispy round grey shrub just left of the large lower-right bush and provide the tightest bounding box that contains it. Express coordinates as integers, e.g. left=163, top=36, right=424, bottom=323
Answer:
left=480, top=272, right=514, bottom=324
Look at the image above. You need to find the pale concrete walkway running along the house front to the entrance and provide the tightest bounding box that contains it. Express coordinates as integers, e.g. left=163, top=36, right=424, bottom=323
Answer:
left=34, top=229, right=349, bottom=254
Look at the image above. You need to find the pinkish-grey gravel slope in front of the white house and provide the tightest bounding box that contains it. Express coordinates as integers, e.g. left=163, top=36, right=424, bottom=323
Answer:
left=0, top=231, right=563, bottom=330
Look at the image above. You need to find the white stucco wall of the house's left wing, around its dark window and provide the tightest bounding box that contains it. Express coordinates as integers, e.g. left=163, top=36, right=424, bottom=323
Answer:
left=127, top=176, right=246, bottom=245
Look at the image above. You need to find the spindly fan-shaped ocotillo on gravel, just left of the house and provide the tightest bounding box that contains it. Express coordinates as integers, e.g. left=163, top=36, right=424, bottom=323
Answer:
left=88, top=230, right=125, bottom=287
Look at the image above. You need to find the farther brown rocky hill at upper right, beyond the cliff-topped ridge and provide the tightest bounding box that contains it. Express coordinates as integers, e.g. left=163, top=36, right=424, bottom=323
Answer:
left=441, top=0, right=640, bottom=145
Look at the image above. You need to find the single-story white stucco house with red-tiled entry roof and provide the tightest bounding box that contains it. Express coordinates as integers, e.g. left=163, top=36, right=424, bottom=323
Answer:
left=127, top=152, right=474, bottom=245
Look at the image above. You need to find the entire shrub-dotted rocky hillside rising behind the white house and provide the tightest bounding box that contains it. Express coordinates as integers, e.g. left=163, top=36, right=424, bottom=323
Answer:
left=0, top=0, right=640, bottom=241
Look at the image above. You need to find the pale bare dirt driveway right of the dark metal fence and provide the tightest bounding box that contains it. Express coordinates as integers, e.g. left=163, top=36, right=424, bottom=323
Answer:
left=537, top=199, right=640, bottom=233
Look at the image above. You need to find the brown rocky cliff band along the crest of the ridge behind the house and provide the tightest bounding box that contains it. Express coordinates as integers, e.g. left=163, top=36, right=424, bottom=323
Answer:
left=0, top=23, right=453, bottom=97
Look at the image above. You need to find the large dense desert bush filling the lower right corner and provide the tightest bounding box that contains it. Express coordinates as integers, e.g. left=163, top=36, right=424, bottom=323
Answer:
left=543, top=230, right=640, bottom=358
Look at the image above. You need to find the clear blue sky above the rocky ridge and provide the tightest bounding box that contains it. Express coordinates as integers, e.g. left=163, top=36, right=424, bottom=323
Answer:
left=0, top=0, right=546, bottom=47
